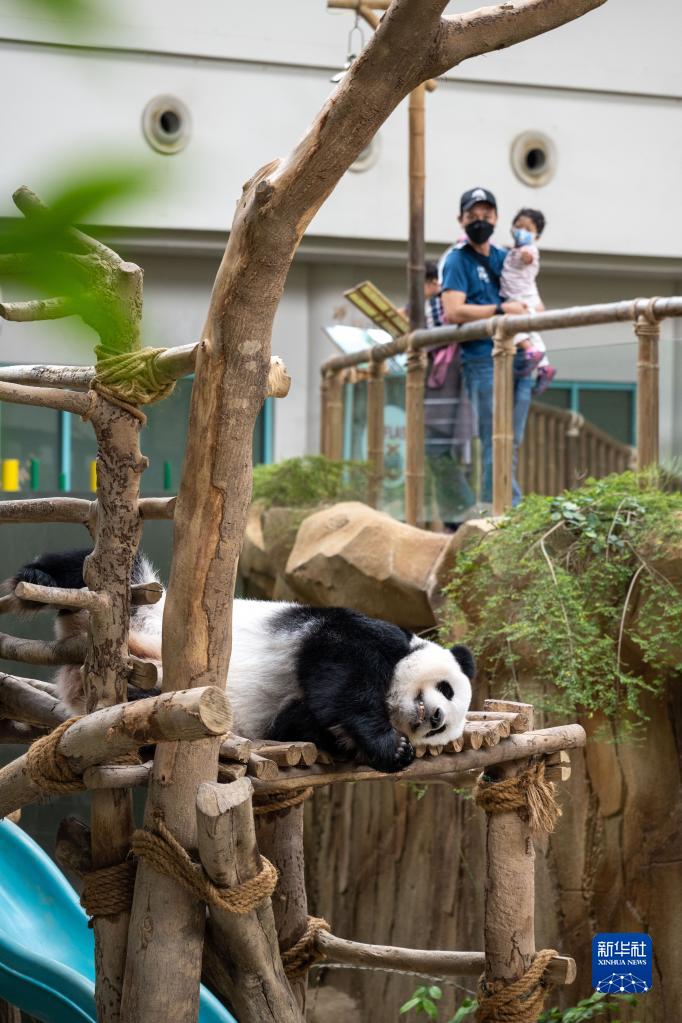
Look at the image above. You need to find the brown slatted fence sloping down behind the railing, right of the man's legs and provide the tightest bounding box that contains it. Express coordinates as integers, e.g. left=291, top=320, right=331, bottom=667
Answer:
left=516, top=403, right=637, bottom=494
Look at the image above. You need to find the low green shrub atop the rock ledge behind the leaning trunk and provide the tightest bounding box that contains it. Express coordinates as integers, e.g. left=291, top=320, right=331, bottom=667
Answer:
left=253, top=455, right=370, bottom=507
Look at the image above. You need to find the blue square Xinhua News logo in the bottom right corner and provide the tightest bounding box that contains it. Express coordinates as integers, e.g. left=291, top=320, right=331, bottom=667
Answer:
left=592, top=934, right=653, bottom=994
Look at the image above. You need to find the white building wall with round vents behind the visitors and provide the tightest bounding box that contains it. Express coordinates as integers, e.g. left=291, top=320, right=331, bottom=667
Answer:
left=0, top=0, right=682, bottom=457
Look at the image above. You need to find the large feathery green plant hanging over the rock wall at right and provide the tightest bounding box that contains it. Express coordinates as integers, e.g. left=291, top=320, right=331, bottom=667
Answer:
left=444, top=473, right=682, bottom=725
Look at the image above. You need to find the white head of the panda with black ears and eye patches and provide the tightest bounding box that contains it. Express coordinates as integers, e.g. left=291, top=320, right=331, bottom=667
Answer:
left=387, top=638, right=474, bottom=746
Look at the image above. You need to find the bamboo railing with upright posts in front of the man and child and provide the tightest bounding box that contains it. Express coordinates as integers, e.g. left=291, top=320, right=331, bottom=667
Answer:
left=320, top=296, right=682, bottom=524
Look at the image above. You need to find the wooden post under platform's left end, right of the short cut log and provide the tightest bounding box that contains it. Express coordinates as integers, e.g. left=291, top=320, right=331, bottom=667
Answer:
left=256, top=803, right=308, bottom=1014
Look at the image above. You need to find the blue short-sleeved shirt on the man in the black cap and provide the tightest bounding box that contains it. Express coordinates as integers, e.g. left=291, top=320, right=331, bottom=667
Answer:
left=442, top=244, right=507, bottom=362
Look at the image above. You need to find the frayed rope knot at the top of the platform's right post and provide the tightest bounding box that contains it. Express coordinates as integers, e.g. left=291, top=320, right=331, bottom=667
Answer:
left=473, top=759, right=561, bottom=834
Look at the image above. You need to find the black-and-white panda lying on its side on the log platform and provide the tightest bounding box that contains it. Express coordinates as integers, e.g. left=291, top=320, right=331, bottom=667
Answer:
left=6, top=550, right=474, bottom=771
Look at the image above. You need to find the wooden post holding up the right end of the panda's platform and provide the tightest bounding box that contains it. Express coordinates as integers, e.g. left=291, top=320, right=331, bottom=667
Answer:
left=484, top=760, right=536, bottom=991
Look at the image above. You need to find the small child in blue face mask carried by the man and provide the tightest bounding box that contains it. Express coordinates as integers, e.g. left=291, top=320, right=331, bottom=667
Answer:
left=500, top=209, right=556, bottom=395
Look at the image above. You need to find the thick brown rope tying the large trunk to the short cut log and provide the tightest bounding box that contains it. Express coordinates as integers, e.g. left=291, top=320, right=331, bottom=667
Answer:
left=132, top=820, right=277, bottom=914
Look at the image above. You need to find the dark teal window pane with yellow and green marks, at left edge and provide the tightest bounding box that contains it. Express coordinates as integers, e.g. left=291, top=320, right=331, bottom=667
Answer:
left=0, top=403, right=59, bottom=494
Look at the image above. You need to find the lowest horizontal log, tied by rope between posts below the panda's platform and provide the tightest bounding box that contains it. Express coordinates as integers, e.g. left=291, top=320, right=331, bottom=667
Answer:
left=315, top=931, right=576, bottom=985
